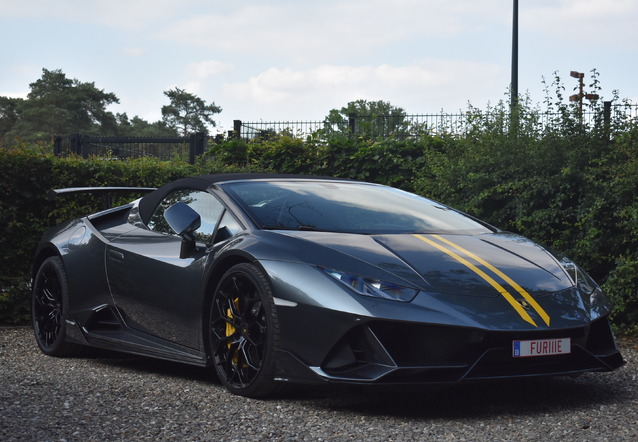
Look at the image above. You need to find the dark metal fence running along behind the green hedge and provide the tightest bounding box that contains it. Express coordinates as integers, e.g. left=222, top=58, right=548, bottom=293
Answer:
left=53, top=102, right=638, bottom=164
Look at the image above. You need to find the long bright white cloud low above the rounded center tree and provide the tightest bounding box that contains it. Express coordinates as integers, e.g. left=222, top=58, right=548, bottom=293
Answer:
left=222, top=59, right=504, bottom=119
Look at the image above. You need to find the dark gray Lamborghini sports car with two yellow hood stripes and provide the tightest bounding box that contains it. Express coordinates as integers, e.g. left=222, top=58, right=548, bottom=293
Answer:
left=32, top=174, right=624, bottom=397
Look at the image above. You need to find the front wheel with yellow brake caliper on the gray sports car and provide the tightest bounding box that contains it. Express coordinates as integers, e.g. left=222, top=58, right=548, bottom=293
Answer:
left=208, top=263, right=279, bottom=398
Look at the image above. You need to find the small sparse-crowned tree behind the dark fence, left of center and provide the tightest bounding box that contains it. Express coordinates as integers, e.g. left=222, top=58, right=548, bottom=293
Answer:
left=162, top=88, right=222, bottom=136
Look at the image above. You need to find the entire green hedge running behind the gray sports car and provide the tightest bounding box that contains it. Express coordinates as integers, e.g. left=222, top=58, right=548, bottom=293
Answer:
left=0, top=119, right=638, bottom=331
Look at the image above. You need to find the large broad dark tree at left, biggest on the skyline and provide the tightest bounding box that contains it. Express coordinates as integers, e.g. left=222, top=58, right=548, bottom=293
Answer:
left=9, top=69, right=119, bottom=140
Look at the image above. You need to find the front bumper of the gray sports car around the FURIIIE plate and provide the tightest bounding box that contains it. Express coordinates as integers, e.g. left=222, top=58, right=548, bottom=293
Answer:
left=278, top=317, right=624, bottom=385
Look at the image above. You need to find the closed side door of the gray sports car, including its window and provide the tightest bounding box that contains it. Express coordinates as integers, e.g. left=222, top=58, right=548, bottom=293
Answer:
left=106, top=189, right=229, bottom=349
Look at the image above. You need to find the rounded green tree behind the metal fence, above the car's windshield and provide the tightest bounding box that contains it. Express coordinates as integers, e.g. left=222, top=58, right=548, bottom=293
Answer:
left=324, top=100, right=407, bottom=138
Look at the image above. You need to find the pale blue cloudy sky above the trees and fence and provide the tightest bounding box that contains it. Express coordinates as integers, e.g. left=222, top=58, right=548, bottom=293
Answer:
left=0, top=0, right=638, bottom=132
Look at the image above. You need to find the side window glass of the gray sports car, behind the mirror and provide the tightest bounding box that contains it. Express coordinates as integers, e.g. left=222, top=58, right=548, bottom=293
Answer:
left=148, top=189, right=224, bottom=244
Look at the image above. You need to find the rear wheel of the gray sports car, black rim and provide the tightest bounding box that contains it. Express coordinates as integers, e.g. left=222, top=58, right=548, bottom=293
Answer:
left=31, top=256, right=82, bottom=356
